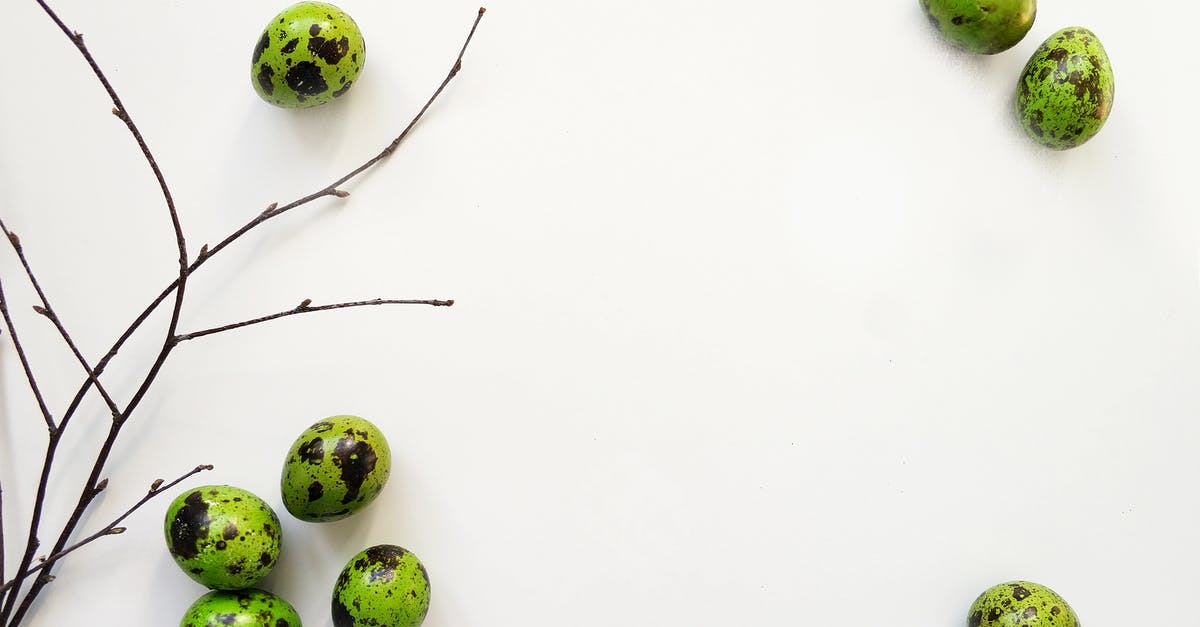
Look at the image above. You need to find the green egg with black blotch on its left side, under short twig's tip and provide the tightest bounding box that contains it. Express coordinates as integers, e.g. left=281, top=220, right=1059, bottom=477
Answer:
left=164, top=485, right=282, bottom=590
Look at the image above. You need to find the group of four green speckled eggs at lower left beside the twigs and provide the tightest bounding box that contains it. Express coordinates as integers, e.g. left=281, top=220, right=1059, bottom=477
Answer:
left=163, top=416, right=430, bottom=627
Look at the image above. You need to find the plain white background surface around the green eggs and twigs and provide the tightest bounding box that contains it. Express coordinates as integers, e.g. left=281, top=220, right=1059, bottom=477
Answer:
left=0, top=0, right=1200, bottom=627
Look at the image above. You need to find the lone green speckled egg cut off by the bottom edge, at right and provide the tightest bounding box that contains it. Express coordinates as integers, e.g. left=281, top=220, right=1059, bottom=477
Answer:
left=967, top=581, right=1079, bottom=627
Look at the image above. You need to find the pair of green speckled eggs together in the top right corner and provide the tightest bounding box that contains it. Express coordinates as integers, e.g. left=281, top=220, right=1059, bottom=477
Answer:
left=920, top=0, right=1114, bottom=150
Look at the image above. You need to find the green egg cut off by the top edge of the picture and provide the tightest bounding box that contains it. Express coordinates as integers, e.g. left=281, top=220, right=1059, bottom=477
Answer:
left=920, top=0, right=1038, bottom=54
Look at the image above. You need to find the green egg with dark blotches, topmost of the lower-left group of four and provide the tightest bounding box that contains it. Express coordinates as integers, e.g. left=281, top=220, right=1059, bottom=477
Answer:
left=280, top=416, right=391, bottom=523
